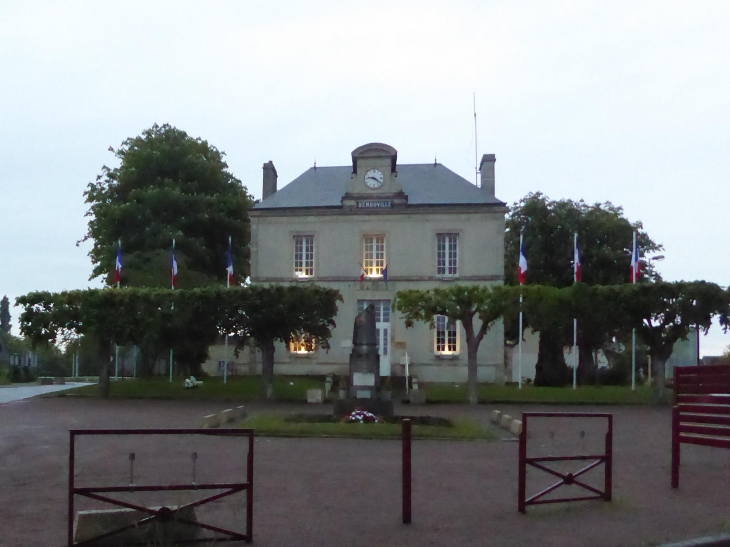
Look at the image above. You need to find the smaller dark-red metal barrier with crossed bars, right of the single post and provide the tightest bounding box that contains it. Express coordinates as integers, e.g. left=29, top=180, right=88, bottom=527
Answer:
left=517, top=412, right=613, bottom=513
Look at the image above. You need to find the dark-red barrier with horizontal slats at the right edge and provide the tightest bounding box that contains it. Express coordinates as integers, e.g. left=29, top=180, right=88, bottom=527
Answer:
left=672, top=365, right=730, bottom=488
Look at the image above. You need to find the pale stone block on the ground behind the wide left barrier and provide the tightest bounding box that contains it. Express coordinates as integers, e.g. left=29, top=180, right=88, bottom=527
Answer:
left=74, top=506, right=200, bottom=547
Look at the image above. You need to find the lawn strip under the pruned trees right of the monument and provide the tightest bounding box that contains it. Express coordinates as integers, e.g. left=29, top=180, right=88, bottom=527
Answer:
left=425, top=383, right=671, bottom=405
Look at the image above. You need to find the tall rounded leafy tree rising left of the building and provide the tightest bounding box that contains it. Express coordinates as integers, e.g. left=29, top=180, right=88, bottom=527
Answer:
left=81, top=124, right=253, bottom=288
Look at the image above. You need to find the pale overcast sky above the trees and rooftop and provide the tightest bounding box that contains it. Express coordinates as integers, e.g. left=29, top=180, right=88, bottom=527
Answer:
left=0, top=0, right=730, bottom=354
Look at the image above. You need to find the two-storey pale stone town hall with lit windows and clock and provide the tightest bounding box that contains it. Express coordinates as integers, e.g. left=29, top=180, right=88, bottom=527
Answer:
left=250, top=143, right=507, bottom=382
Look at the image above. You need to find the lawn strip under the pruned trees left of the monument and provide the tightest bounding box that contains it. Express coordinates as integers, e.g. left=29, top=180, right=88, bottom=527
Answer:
left=61, top=376, right=324, bottom=402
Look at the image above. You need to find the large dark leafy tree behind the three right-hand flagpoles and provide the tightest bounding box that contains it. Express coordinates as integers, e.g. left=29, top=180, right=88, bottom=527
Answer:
left=505, top=193, right=662, bottom=385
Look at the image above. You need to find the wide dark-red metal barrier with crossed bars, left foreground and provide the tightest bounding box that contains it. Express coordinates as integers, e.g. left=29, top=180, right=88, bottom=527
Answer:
left=68, top=429, right=254, bottom=547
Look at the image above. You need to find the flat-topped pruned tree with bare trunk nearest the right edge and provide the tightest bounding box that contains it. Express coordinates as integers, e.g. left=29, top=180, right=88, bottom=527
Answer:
left=614, top=281, right=730, bottom=403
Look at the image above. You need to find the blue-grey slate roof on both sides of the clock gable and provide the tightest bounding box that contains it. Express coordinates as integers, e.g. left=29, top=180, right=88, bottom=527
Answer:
left=254, top=163, right=504, bottom=209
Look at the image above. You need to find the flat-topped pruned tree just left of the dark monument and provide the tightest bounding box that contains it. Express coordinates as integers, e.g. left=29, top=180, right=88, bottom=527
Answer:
left=221, top=285, right=342, bottom=399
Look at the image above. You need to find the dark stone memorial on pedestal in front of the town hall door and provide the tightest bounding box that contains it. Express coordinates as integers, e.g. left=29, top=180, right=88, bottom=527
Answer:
left=334, top=304, right=393, bottom=418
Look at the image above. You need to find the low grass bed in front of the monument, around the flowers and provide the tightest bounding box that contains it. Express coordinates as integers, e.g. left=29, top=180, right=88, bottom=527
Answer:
left=238, top=413, right=496, bottom=440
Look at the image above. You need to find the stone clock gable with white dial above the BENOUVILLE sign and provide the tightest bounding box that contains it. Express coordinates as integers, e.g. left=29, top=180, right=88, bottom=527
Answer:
left=342, top=142, right=408, bottom=209
